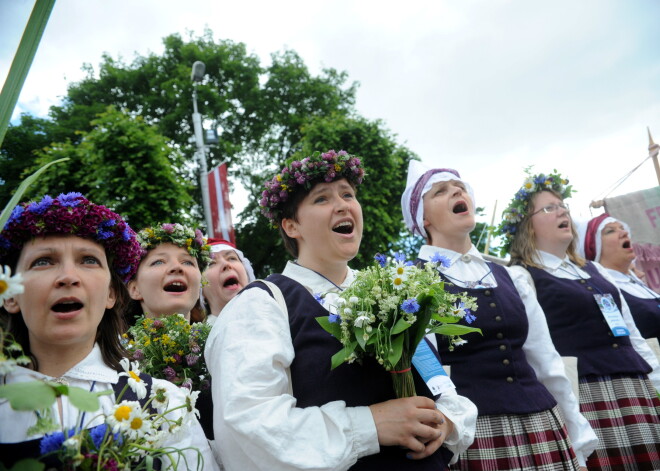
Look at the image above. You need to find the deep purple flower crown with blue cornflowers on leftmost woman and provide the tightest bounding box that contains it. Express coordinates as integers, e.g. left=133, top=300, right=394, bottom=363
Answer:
left=0, top=192, right=141, bottom=281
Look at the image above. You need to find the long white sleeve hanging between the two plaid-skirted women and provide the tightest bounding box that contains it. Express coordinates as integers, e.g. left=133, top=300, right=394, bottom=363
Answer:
left=508, top=267, right=598, bottom=466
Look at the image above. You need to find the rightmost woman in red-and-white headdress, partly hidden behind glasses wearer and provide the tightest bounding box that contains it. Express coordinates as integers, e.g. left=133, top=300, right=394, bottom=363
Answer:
left=578, top=213, right=660, bottom=339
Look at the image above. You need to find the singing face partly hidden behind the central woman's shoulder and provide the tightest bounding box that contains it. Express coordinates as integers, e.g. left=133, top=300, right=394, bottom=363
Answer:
left=202, top=250, right=248, bottom=315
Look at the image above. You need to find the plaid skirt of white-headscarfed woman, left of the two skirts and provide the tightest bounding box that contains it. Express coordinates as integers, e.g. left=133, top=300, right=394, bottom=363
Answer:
left=450, top=406, right=579, bottom=471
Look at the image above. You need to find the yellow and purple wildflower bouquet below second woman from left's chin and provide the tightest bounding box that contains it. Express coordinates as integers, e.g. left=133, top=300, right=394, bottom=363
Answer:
left=124, top=314, right=211, bottom=391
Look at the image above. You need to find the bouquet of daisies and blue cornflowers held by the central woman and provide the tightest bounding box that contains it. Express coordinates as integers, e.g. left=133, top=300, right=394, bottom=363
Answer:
left=317, top=253, right=481, bottom=397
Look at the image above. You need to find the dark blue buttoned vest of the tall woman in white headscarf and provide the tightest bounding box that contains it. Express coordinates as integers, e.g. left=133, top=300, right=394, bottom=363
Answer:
left=422, top=263, right=557, bottom=415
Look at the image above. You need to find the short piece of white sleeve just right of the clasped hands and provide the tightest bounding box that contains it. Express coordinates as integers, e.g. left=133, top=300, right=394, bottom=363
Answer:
left=435, top=389, right=477, bottom=464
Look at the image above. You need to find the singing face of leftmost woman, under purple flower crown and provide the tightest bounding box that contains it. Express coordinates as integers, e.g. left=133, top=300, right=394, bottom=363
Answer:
left=5, top=236, right=116, bottom=358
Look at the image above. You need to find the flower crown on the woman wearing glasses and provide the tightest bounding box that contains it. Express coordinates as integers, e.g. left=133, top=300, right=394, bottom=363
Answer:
left=497, top=170, right=573, bottom=253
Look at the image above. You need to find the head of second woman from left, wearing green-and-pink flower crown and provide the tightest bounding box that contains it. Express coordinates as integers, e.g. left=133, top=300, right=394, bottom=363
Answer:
left=128, top=223, right=210, bottom=322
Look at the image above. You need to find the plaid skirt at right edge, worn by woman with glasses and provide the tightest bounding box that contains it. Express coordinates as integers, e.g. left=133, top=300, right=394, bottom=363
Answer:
left=580, top=375, right=660, bottom=471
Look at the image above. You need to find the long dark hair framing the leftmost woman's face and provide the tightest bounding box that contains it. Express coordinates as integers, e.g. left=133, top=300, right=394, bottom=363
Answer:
left=0, top=251, right=128, bottom=370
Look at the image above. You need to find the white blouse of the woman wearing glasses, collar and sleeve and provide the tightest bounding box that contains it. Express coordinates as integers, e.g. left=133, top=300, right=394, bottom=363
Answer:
left=512, top=250, right=660, bottom=391
